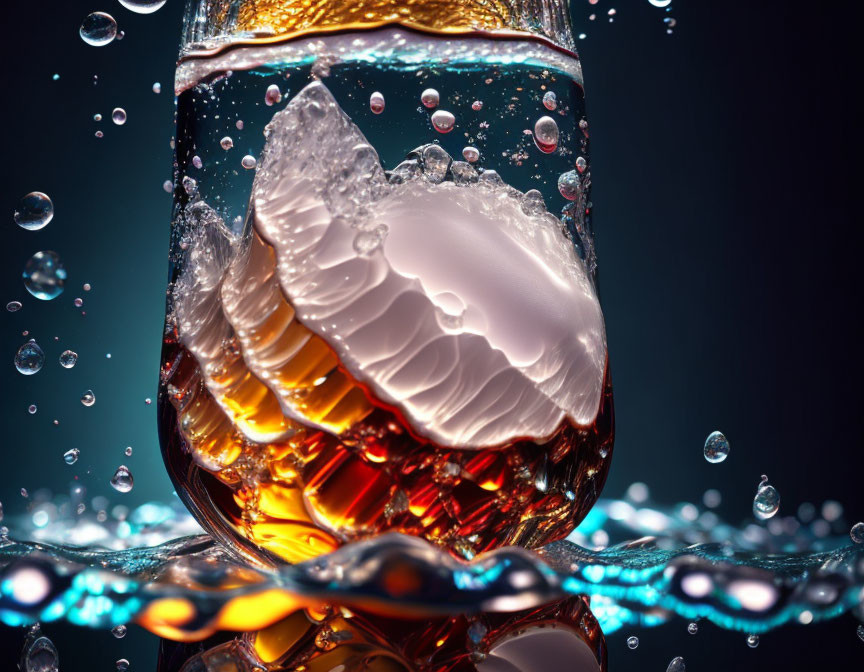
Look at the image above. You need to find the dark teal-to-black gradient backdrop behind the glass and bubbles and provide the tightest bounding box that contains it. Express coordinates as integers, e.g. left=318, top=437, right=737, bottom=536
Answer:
left=0, top=0, right=864, bottom=672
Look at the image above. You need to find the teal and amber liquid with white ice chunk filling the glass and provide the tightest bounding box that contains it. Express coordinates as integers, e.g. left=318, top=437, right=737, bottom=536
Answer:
left=159, top=23, right=613, bottom=564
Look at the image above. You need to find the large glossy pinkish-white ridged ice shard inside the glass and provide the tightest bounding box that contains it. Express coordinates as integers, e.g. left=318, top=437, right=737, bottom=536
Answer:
left=235, top=82, right=606, bottom=448
